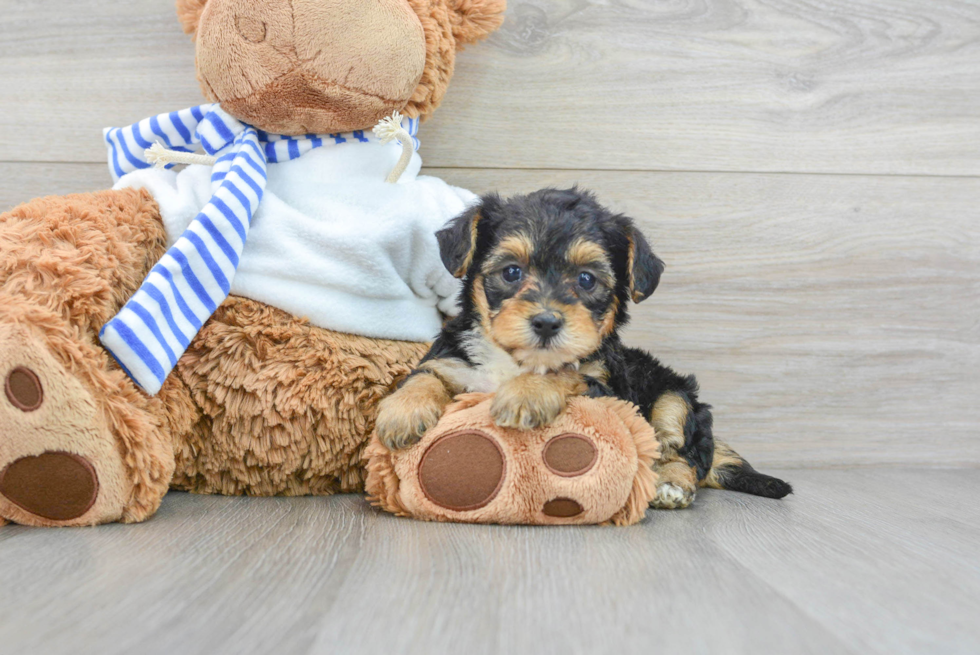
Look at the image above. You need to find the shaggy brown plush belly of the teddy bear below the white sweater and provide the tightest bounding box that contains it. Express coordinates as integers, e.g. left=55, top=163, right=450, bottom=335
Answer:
left=171, top=297, right=426, bottom=496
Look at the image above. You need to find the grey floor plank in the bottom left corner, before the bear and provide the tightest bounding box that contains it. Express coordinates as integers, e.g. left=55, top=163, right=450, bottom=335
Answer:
left=0, top=494, right=377, bottom=653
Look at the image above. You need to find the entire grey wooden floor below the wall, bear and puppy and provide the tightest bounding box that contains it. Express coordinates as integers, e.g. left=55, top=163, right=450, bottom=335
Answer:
left=0, top=468, right=980, bottom=655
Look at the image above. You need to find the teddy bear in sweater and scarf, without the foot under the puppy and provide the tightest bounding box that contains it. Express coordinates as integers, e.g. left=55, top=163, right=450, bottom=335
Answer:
left=0, top=0, right=505, bottom=526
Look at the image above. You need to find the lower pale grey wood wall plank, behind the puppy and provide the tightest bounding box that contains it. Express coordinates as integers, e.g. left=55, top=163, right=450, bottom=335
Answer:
left=0, top=164, right=980, bottom=466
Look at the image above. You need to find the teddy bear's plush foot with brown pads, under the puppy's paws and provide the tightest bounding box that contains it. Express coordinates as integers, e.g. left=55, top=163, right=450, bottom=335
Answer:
left=367, top=394, right=658, bottom=525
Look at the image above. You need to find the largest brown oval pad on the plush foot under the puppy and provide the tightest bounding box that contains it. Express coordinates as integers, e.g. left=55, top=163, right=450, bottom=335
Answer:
left=419, top=432, right=505, bottom=512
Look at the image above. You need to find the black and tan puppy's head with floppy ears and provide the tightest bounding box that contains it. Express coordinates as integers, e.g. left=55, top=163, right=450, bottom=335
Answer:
left=438, top=189, right=663, bottom=371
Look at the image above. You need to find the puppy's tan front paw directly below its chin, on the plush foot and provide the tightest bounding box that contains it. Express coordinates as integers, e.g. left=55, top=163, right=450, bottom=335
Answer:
left=490, top=375, right=568, bottom=430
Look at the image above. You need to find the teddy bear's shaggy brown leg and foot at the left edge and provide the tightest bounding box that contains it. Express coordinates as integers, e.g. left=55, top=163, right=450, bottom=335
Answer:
left=0, top=190, right=174, bottom=526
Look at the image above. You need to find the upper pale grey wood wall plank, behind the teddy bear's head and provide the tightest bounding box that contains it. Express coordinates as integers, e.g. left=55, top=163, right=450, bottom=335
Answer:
left=0, top=0, right=980, bottom=175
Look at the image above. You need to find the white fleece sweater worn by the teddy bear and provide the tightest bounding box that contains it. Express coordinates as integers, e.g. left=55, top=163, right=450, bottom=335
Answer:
left=114, top=132, right=476, bottom=341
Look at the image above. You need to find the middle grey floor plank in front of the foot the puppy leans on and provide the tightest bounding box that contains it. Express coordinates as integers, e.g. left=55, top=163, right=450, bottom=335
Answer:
left=313, top=492, right=851, bottom=655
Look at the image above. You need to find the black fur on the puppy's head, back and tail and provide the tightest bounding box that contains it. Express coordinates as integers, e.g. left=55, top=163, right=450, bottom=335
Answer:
left=422, top=188, right=791, bottom=498
